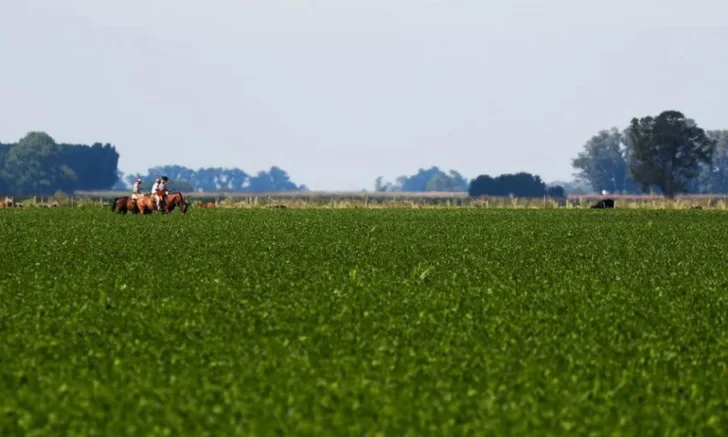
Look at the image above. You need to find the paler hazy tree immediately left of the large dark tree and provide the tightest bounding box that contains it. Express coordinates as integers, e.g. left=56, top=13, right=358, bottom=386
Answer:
left=571, top=127, right=629, bottom=193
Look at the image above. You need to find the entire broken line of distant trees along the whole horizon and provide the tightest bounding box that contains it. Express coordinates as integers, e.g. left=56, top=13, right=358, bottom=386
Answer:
left=7, top=111, right=728, bottom=197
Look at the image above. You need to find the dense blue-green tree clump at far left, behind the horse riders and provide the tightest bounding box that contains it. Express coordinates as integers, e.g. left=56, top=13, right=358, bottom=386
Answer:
left=0, top=132, right=119, bottom=196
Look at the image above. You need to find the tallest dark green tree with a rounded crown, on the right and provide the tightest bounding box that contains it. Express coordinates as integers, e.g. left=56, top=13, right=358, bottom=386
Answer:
left=629, top=111, right=715, bottom=198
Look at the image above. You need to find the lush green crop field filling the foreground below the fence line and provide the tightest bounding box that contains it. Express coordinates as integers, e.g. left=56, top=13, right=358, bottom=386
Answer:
left=0, top=209, right=728, bottom=436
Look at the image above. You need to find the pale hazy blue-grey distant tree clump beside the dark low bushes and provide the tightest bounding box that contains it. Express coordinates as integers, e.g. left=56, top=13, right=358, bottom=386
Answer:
left=374, top=167, right=468, bottom=192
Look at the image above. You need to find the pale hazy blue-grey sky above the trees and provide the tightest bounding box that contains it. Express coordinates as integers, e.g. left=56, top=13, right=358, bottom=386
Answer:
left=0, top=0, right=728, bottom=189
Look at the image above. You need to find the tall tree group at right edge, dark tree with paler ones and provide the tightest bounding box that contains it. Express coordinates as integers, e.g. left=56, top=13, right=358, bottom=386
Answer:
left=567, top=111, right=728, bottom=197
